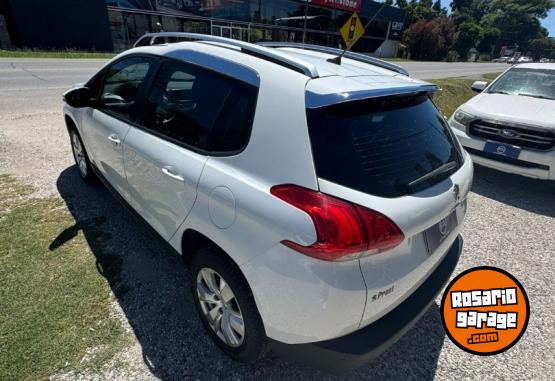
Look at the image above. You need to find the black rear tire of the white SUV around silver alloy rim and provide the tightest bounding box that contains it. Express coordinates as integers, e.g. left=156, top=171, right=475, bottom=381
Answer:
left=191, top=246, right=268, bottom=363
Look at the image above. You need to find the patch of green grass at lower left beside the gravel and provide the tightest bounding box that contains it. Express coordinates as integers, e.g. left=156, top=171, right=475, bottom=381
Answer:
left=0, top=175, right=129, bottom=380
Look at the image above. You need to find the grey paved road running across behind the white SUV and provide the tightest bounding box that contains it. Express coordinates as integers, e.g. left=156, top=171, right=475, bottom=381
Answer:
left=0, top=58, right=508, bottom=91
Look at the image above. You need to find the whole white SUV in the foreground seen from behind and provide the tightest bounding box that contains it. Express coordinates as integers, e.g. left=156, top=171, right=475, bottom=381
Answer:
left=64, top=34, right=473, bottom=371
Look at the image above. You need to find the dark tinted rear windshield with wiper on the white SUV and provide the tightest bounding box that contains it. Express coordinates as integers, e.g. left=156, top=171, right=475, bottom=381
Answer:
left=307, top=95, right=463, bottom=198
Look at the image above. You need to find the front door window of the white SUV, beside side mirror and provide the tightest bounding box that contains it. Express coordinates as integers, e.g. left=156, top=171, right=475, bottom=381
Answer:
left=99, top=57, right=154, bottom=118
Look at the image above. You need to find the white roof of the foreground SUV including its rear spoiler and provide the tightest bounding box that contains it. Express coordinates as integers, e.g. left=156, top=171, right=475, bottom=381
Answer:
left=123, top=40, right=439, bottom=108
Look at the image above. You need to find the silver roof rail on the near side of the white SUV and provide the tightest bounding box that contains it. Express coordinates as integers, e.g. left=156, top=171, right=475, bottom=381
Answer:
left=135, top=32, right=319, bottom=78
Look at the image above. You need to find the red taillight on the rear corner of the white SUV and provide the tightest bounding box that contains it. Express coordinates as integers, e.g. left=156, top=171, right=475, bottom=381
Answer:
left=270, top=185, right=404, bottom=261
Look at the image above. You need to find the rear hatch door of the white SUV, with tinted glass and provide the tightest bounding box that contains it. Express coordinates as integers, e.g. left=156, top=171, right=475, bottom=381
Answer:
left=307, top=81, right=472, bottom=326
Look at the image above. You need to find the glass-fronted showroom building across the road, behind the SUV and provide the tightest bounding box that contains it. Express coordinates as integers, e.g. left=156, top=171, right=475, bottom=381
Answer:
left=106, top=0, right=406, bottom=57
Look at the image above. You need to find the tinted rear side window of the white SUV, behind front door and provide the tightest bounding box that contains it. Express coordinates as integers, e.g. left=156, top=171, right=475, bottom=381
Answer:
left=143, top=62, right=257, bottom=152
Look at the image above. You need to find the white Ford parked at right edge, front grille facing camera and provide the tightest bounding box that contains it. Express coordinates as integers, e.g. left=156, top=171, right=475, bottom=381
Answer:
left=449, top=64, right=555, bottom=180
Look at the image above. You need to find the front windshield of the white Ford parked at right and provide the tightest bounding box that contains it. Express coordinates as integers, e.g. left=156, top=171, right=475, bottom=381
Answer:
left=488, top=68, right=555, bottom=100
